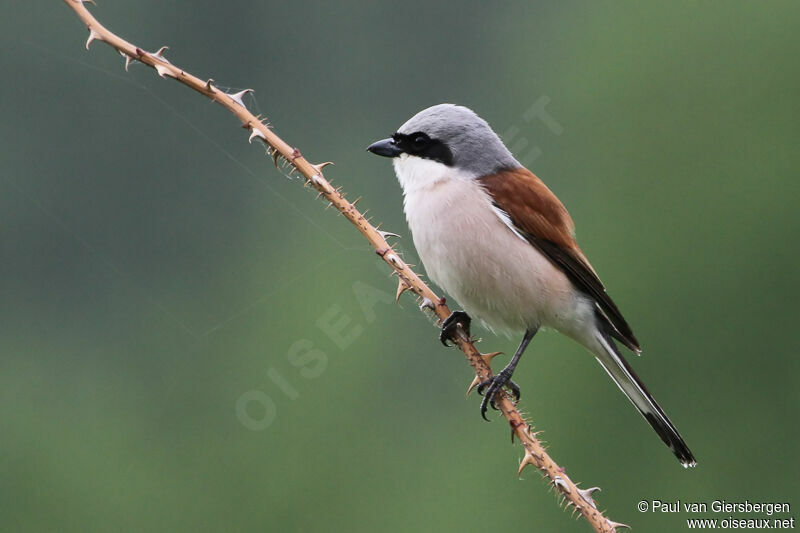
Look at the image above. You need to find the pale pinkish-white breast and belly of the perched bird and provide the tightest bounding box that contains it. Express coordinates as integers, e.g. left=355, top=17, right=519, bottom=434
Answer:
left=405, top=172, right=594, bottom=338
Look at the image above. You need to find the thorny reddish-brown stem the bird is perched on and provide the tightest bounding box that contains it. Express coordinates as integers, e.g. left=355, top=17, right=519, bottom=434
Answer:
left=64, top=0, right=627, bottom=533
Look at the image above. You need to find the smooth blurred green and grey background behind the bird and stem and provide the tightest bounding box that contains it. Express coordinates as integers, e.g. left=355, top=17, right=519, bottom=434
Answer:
left=0, top=0, right=800, bottom=532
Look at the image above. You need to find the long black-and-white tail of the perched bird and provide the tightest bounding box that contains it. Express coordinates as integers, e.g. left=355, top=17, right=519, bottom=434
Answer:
left=595, top=331, right=697, bottom=468
